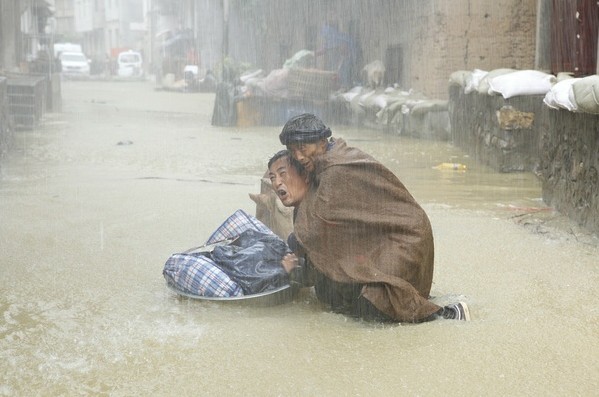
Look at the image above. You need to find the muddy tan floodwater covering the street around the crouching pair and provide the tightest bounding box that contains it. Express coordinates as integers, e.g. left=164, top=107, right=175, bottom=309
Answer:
left=0, top=81, right=599, bottom=396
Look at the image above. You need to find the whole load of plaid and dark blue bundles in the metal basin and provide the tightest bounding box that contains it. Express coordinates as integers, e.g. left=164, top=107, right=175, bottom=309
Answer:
left=162, top=210, right=290, bottom=298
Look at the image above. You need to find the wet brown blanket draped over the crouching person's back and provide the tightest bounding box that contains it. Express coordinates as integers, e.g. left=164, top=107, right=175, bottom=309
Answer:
left=294, top=139, right=440, bottom=322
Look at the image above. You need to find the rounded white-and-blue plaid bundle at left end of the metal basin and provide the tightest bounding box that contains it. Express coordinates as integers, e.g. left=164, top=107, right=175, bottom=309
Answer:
left=162, top=254, right=243, bottom=298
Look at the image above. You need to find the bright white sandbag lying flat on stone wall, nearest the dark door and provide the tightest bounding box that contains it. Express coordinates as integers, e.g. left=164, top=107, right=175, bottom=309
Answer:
left=489, top=70, right=556, bottom=99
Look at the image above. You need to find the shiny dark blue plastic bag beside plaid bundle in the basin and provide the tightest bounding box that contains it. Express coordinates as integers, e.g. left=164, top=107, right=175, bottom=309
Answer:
left=210, top=229, right=290, bottom=295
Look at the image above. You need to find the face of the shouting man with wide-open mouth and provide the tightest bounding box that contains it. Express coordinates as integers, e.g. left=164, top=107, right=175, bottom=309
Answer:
left=268, top=156, right=308, bottom=207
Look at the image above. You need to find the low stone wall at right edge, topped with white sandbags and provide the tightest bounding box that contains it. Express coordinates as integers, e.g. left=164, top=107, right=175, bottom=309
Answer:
left=449, top=85, right=599, bottom=233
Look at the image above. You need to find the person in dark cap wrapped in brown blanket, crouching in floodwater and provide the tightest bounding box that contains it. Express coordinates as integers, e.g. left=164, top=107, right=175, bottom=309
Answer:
left=279, top=114, right=470, bottom=323
